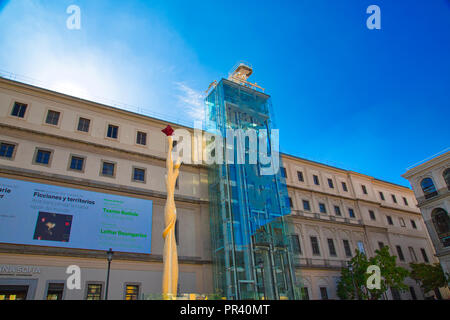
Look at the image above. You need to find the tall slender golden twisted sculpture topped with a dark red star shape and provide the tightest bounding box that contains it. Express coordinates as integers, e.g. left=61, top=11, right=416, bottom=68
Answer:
left=162, top=126, right=181, bottom=300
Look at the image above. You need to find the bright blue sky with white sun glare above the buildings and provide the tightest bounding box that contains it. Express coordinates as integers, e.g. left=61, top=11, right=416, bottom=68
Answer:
left=0, top=0, right=450, bottom=186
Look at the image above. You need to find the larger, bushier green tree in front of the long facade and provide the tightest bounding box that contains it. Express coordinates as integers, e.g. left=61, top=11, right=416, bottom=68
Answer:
left=337, top=246, right=409, bottom=300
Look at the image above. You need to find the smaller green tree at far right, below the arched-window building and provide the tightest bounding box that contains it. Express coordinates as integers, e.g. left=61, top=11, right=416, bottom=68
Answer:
left=409, top=263, right=450, bottom=297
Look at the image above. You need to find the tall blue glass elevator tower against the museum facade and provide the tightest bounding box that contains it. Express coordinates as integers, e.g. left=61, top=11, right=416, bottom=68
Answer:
left=205, top=64, right=300, bottom=299
